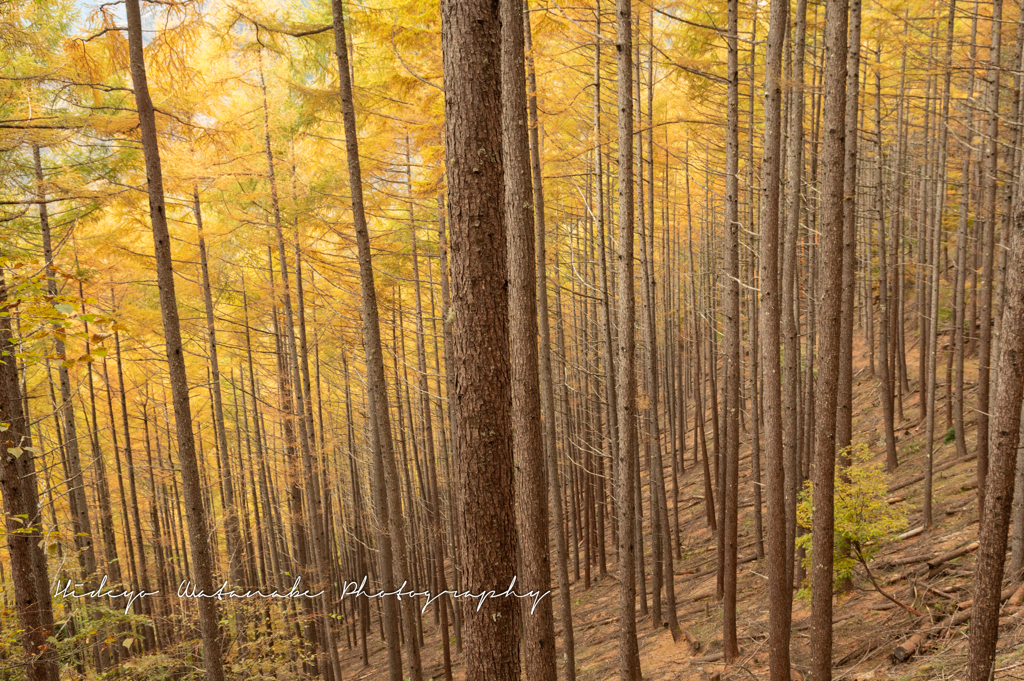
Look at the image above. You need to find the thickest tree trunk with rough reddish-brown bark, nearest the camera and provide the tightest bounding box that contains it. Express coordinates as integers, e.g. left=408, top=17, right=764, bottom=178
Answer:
left=441, top=0, right=520, bottom=681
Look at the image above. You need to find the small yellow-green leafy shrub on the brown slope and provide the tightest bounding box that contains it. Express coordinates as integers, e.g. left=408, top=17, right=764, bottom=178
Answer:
left=797, top=443, right=906, bottom=584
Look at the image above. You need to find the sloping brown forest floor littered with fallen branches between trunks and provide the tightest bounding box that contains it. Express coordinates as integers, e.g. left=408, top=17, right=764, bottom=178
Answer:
left=342, top=331, right=1024, bottom=681
